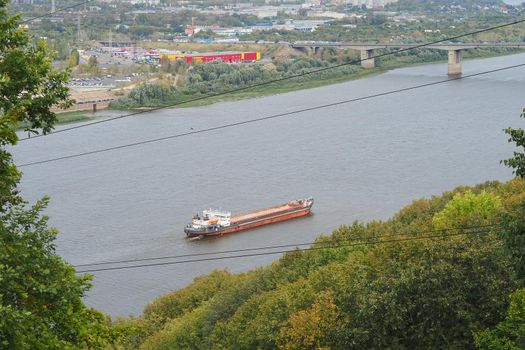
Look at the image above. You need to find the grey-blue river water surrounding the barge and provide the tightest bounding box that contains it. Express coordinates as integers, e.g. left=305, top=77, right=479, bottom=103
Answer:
left=14, top=54, right=525, bottom=315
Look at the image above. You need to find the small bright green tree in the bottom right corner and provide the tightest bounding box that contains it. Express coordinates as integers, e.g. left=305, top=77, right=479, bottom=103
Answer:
left=475, top=289, right=525, bottom=350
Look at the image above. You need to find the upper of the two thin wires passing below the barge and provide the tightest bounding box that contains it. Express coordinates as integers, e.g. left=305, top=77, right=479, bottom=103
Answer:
left=73, top=224, right=501, bottom=268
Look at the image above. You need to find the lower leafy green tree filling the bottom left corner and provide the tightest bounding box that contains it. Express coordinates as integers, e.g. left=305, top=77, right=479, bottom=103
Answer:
left=0, top=199, right=107, bottom=349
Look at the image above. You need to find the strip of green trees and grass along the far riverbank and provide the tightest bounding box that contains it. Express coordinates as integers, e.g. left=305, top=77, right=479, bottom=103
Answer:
left=109, top=49, right=523, bottom=110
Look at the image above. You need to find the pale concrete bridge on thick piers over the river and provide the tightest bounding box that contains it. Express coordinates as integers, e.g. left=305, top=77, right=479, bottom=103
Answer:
left=290, top=41, right=525, bottom=76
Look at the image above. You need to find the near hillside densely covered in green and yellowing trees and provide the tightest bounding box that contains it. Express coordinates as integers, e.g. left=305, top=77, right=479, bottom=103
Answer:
left=114, top=179, right=525, bottom=349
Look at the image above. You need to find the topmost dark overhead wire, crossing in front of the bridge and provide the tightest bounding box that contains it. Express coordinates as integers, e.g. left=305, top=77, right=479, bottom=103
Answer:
left=19, top=19, right=525, bottom=141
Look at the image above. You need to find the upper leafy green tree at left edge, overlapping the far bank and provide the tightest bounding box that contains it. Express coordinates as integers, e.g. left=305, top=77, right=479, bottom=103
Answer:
left=0, top=0, right=71, bottom=210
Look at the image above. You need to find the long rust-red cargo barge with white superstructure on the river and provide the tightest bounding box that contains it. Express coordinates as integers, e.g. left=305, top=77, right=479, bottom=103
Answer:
left=184, top=198, right=314, bottom=238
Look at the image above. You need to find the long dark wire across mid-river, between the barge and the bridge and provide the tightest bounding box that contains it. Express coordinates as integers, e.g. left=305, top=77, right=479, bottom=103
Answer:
left=19, top=63, right=525, bottom=167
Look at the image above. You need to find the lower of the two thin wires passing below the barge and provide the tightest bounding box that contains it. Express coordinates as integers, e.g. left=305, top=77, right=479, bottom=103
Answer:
left=77, top=230, right=491, bottom=273
